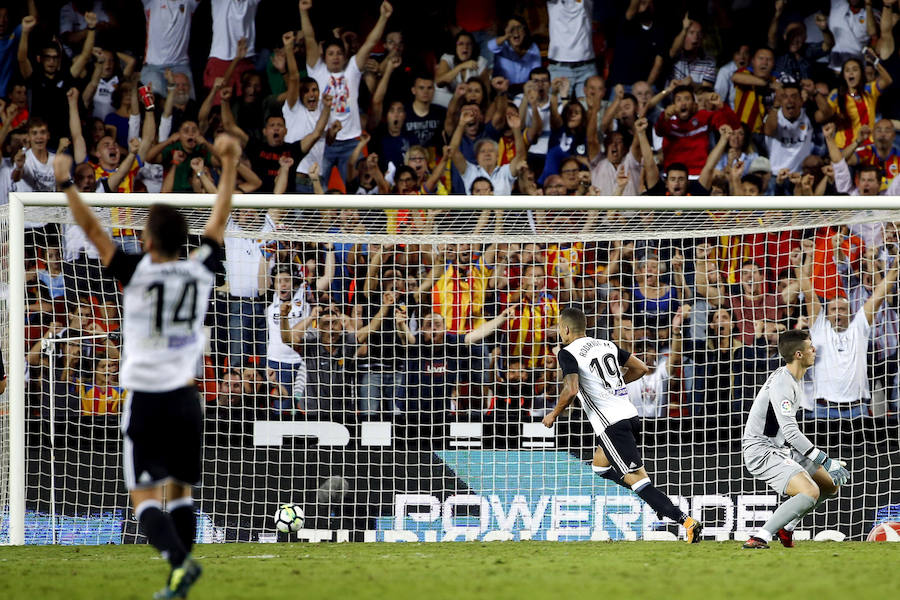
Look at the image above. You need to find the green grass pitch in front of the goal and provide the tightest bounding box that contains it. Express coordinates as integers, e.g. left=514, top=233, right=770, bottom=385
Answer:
left=0, top=542, right=900, bottom=600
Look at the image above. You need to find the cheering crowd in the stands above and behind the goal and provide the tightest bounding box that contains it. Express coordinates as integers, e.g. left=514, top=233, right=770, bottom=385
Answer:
left=0, top=0, right=900, bottom=426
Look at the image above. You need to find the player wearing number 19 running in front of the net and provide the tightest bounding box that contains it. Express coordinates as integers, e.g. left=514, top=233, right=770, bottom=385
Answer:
left=543, top=307, right=703, bottom=543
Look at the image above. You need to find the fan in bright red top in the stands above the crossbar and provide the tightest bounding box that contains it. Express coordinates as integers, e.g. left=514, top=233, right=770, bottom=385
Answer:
left=656, top=85, right=740, bottom=176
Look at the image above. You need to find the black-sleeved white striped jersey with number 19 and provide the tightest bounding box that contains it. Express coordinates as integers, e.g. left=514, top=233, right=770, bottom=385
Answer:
left=558, top=336, right=638, bottom=435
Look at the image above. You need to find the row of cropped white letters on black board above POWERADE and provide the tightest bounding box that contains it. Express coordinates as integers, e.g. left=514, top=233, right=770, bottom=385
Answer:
left=253, top=421, right=556, bottom=448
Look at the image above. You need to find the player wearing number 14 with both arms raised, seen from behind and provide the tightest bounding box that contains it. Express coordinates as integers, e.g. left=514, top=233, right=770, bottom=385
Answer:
left=53, top=135, right=241, bottom=598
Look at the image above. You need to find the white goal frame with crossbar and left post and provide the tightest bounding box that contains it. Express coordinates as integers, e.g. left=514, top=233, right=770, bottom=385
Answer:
left=0, top=193, right=900, bottom=545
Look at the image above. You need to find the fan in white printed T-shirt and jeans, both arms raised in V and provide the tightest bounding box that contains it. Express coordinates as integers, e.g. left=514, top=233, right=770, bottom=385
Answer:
left=299, top=0, right=394, bottom=181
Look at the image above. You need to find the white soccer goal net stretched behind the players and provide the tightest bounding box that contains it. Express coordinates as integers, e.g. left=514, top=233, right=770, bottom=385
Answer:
left=0, top=195, right=900, bottom=544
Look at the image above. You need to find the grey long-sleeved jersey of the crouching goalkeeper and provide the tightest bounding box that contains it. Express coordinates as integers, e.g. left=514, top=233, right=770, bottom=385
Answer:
left=742, top=367, right=815, bottom=455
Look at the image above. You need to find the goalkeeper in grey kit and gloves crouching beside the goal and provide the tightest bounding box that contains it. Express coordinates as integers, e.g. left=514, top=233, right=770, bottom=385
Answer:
left=741, top=329, right=850, bottom=549
